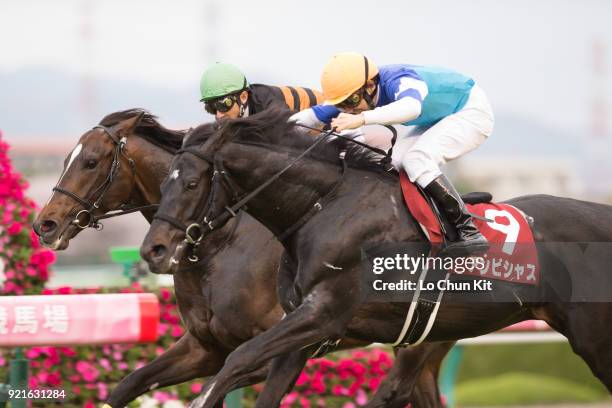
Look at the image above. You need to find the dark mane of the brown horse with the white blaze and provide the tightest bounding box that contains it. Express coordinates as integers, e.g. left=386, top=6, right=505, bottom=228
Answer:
left=100, top=108, right=187, bottom=153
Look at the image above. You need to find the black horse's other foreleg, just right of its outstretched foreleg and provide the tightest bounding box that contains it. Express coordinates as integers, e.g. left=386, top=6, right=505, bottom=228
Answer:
left=255, top=350, right=309, bottom=408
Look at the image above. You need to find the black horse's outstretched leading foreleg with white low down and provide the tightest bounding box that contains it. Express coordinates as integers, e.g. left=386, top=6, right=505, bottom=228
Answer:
left=190, top=291, right=352, bottom=408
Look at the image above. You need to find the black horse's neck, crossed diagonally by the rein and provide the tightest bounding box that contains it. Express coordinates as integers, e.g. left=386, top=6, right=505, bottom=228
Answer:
left=223, top=145, right=341, bottom=235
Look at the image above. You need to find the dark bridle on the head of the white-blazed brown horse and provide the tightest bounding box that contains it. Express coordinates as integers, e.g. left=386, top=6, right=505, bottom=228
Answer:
left=53, top=125, right=153, bottom=230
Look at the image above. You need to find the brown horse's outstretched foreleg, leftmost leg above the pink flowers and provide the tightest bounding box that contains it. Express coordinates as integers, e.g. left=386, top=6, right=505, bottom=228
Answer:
left=107, top=332, right=227, bottom=408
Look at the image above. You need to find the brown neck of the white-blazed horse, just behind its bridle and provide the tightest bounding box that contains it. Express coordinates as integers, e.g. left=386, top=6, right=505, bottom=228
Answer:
left=128, top=137, right=173, bottom=221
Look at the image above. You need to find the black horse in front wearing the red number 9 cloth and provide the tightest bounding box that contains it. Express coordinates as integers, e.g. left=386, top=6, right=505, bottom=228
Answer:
left=142, top=108, right=612, bottom=407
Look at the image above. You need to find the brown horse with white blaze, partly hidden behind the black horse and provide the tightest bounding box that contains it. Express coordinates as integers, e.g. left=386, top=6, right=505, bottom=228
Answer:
left=34, top=110, right=452, bottom=408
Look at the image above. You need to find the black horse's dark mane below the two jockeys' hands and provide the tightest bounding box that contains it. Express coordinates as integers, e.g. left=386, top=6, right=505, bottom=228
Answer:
left=185, top=108, right=390, bottom=174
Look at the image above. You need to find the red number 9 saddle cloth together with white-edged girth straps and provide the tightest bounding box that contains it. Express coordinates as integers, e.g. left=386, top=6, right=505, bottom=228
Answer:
left=393, top=172, right=539, bottom=346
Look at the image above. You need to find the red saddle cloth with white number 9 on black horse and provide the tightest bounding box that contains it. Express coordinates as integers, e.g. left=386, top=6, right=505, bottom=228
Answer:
left=400, top=171, right=540, bottom=285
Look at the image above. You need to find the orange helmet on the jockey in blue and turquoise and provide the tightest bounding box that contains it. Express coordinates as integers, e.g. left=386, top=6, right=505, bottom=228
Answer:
left=321, top=52, right=378, bottom=105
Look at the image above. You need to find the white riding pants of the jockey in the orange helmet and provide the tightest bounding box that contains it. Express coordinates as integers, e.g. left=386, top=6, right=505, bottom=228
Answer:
left=363, top=85, right=494, bottom=187
